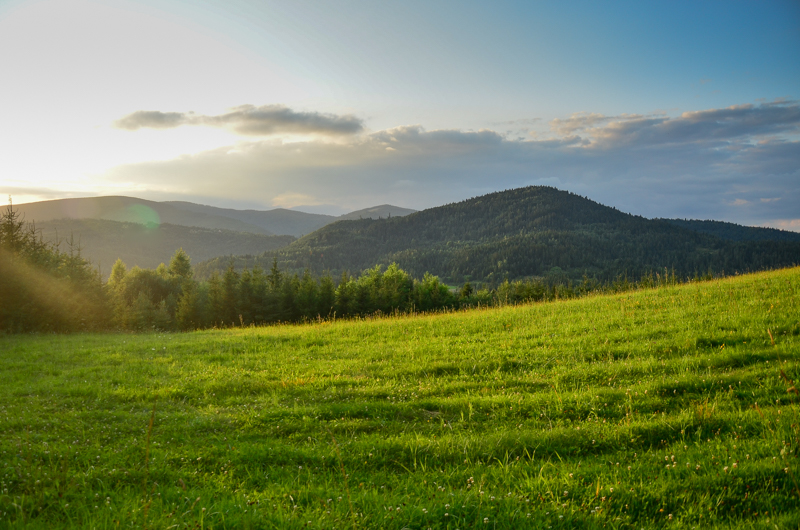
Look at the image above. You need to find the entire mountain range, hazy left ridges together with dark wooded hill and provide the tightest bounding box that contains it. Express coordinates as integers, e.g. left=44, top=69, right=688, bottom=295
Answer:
left=12, top=187, right=800, bottom=283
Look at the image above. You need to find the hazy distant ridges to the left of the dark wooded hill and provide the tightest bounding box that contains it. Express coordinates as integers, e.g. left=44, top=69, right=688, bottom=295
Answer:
left=14, top=197, right=416, bottom=271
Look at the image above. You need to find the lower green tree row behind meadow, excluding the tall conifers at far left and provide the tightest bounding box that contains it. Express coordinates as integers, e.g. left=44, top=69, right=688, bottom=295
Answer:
left=106, top=249, right=692, bottom=331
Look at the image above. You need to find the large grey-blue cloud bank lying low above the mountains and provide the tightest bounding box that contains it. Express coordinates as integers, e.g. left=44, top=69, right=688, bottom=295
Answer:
left=109, top=101, right=800, bottom=229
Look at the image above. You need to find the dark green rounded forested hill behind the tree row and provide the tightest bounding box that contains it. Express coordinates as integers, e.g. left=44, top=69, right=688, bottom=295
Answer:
left=196, top=187, right=800, bottom=284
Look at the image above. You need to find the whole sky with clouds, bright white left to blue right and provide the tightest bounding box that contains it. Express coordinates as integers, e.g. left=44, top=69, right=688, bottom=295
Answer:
left=0, top=0, right=800, bottom=231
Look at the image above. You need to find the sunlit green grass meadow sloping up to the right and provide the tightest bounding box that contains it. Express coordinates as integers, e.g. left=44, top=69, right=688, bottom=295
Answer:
left=0, top=268, right=800, bottom=529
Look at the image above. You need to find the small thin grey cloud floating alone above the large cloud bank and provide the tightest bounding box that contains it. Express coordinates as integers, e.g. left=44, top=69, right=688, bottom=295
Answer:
left=113, top=105, right=364, bottom=136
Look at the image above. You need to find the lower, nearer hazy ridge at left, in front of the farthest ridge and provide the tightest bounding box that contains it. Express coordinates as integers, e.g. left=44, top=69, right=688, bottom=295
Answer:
left=36, top=219, right=295, bottom=275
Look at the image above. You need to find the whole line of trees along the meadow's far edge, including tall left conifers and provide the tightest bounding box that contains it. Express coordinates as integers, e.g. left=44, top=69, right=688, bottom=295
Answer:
left=0, top=200, right=724, bottom=333
